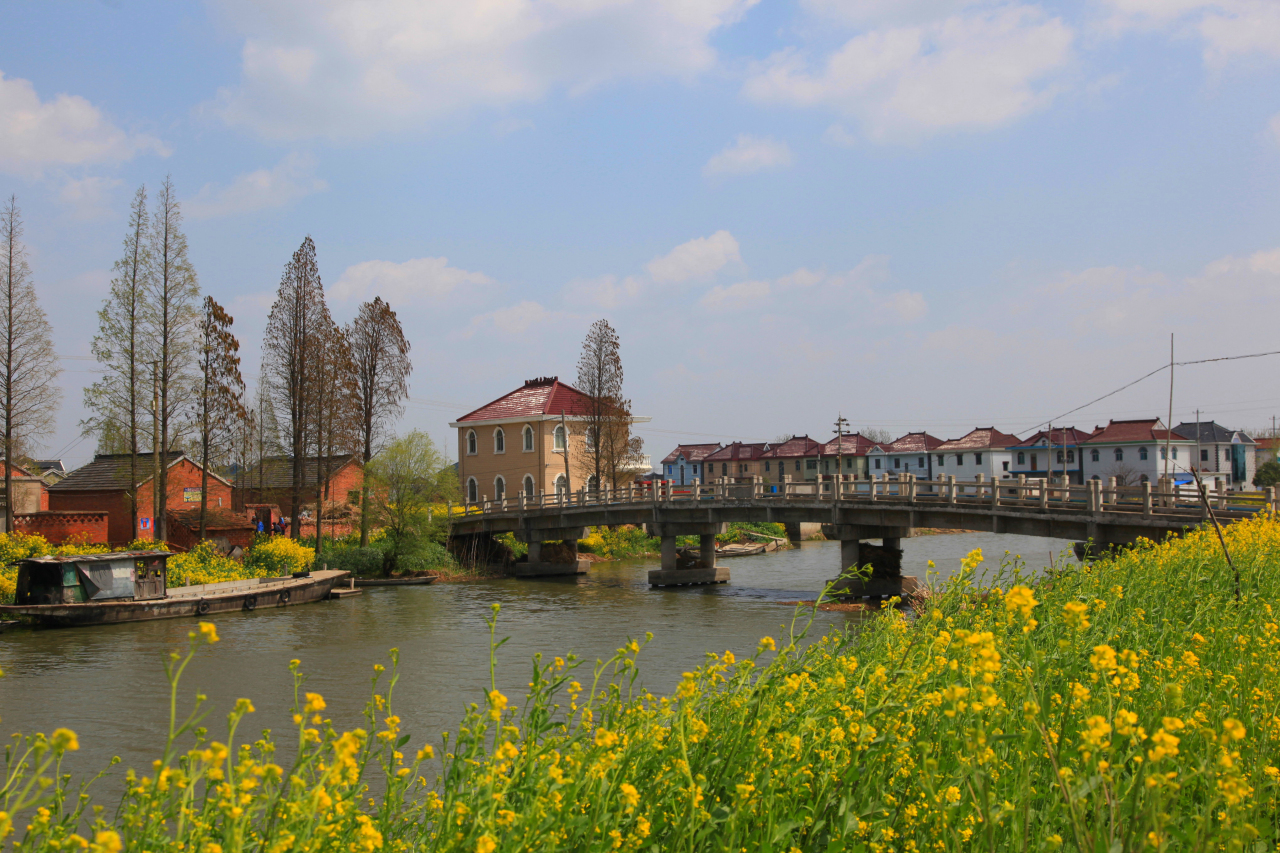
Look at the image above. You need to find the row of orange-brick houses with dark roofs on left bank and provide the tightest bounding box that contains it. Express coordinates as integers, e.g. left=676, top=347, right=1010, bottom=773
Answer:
left=12, top=452, right=364, bottom=549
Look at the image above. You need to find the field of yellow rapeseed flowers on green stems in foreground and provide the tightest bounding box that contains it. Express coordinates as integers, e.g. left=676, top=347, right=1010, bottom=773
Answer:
left=0, top=507, right=1280, bottom=853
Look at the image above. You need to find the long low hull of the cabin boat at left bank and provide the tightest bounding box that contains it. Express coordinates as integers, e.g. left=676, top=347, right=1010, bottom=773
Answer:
left=0, top=571, right=351, bottom=628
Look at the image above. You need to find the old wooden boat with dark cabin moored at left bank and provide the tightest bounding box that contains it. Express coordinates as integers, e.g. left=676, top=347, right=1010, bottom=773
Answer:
left=0, top=551, right=351, bottom=628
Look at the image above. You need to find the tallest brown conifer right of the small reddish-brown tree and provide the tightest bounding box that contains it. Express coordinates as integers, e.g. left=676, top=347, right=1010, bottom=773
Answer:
left=262, top=236, right=332, bottom=539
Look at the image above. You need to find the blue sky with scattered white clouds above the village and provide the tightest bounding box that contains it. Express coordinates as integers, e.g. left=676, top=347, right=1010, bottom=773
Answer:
left=0, top=0, right=1280, bottom=465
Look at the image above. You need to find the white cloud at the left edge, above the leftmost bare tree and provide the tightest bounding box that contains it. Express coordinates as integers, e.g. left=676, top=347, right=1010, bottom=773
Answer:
left=0, top=72, right=169, bottom=174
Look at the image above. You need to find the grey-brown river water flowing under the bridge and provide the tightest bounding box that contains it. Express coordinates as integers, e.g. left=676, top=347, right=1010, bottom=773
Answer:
left=0, top=533, right=1070, bottom=793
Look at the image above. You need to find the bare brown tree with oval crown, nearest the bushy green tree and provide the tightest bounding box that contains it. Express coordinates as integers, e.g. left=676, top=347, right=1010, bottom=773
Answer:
left=346, top=297, right=413, bottom=547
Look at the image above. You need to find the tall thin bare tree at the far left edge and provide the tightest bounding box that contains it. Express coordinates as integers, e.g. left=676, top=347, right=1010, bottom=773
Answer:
left=0, top=196, right=61, bottom=530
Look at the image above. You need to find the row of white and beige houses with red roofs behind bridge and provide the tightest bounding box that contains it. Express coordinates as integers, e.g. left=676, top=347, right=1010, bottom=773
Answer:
left=662, top=418, right=1274, bottom=491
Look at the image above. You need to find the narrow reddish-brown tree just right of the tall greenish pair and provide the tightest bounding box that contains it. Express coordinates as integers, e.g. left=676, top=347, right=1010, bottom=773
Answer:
left=192, top=296, right=246, bottom=539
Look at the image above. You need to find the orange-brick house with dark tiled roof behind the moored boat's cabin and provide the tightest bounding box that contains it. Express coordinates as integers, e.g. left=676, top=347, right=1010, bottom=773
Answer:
left=49, top=451, right=232, bottom=544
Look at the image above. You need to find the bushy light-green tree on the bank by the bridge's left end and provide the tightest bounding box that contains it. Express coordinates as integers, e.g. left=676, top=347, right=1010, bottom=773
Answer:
left=365, top=430, right=458, bottom=574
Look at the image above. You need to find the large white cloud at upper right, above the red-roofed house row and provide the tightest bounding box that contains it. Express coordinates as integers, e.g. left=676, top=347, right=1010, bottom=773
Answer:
left=744, top=5, right=1074, bottom=141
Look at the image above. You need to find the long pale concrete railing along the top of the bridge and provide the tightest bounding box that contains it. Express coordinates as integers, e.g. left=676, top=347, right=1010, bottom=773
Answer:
left=462, top=474, right=1280, bottom=519
